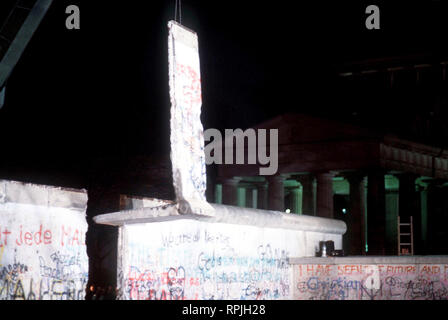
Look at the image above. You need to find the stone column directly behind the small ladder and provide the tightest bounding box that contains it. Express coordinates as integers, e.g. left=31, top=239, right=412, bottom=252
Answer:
left=394, top=173, right=422, bottom=254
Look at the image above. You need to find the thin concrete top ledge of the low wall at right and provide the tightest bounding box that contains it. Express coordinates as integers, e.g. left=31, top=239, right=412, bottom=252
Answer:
left=289, top=256, right=448, bottom=265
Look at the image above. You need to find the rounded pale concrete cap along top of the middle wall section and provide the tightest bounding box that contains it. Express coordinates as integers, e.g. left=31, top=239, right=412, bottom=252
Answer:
left=93, top=199, right=347, bottom=235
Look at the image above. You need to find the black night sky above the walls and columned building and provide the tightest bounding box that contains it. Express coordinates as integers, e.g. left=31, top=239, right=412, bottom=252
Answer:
left=0, top=0, right=448, bottom=185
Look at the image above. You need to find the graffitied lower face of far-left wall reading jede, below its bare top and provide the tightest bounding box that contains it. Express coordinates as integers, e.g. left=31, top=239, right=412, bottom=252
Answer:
left=0, top=208, right=88, bottom=300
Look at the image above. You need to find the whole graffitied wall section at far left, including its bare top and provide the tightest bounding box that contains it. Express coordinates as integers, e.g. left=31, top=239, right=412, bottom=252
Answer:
left=0, top=180, right=88, bottom=300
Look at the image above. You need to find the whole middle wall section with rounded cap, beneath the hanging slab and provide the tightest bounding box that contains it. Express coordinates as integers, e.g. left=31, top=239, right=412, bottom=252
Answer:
left=94, top=204, right=346, bottom=300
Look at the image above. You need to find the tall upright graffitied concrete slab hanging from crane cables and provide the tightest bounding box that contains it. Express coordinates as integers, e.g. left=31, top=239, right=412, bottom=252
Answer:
left=168, top=21, right=207, bottom=202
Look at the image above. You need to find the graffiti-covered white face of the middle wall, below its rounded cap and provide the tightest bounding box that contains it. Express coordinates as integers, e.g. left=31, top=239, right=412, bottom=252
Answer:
left=118, top=220, right=298, bottom=300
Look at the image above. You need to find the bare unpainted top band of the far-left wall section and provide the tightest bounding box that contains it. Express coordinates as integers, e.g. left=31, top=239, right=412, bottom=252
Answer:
left=0, top=180, right=87, bottom=212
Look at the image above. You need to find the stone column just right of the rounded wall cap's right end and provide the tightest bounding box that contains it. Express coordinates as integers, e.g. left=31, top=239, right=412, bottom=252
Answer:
left=345, top=173, right=365, bottom=255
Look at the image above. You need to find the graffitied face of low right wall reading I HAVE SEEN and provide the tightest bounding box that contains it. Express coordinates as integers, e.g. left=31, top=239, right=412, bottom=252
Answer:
left=294, top=264, right=448, bottom=300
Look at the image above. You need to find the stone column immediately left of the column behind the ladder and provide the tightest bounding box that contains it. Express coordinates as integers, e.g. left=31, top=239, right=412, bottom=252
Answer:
left=367, top=170, right=386, bottom=255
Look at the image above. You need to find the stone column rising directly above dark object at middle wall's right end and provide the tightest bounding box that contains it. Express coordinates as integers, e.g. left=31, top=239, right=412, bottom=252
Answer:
left=316, top=172, right=334, bottom=218
